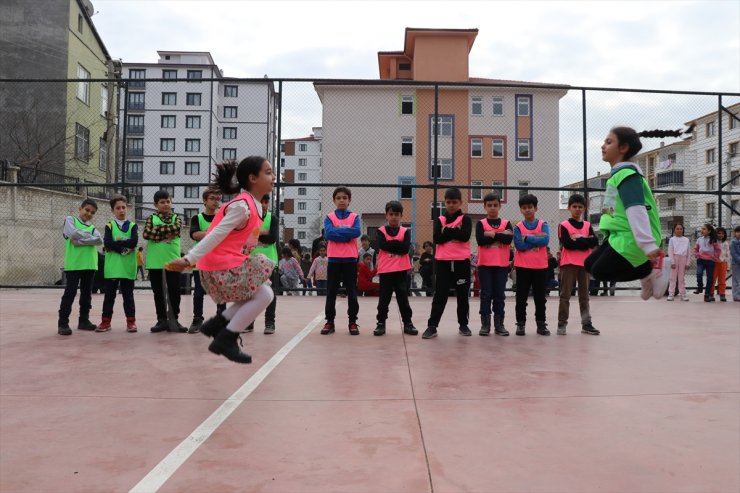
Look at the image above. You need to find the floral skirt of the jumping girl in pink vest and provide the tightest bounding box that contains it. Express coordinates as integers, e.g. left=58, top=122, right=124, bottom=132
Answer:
left=200, top=253, right=275, bottom=304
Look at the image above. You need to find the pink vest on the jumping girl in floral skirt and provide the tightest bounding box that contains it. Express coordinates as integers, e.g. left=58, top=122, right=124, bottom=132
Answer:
left=196, top=192, right=262, bottom=271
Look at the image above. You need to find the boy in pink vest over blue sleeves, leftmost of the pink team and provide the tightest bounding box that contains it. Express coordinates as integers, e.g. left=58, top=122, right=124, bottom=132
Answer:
left=321, top=187, right=361, bottom=336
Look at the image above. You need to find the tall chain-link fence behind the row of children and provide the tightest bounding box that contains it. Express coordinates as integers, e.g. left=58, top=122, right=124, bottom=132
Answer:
left=0, top=77, right=740, bottom=289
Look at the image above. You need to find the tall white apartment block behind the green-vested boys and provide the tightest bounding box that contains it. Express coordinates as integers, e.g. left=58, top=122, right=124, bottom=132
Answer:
left=119, top=51, right=276, bottom=220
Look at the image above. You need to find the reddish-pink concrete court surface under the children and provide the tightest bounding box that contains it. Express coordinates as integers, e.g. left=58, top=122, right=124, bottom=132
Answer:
left=0, top=290, right=740, bottom=493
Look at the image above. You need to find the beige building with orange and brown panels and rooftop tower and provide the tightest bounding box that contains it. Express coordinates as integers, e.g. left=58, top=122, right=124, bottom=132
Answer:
left=315, top=28, right=567, bottom=248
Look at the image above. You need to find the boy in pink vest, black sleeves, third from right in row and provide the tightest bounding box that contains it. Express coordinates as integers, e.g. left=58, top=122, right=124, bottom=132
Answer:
left=475, top=193, right=514, bottom=336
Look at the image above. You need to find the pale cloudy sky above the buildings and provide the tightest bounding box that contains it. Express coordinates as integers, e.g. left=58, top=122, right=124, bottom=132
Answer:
left=92, top=0, right=740, bottom=183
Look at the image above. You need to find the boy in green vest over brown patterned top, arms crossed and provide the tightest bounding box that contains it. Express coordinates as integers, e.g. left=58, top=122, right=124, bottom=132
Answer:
left=142, top=190, right=188, bottom=332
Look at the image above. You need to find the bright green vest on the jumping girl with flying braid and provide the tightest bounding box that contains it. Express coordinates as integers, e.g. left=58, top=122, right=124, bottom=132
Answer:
left=599, top=167, right=661, bottom=267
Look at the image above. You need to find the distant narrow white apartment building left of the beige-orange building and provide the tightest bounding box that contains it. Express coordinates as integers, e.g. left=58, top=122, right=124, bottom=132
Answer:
left=280, top=127, right=323, bottom=244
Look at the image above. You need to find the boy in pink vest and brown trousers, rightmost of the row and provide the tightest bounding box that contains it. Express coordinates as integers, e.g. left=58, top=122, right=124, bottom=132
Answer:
left=558, top=193, right=599, bottom=336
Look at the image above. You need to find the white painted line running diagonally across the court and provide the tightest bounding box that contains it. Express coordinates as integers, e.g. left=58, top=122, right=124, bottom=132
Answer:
left=129, top=312, right=324, bottom=493
